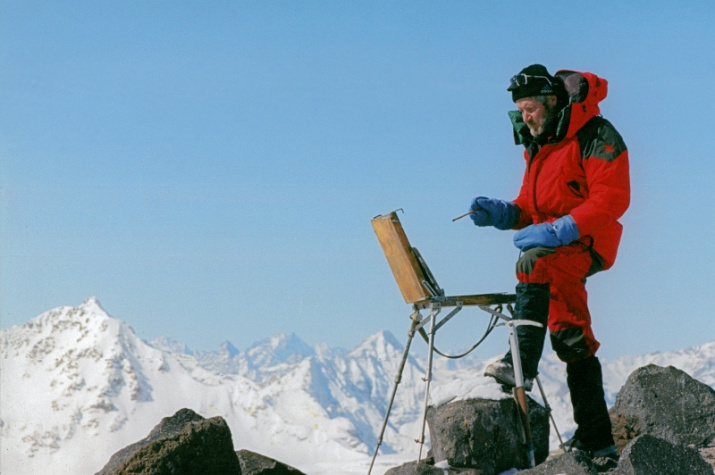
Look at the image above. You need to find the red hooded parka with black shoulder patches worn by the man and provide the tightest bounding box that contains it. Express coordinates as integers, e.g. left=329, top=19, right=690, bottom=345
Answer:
left=510, top=71, right=630, bottom=269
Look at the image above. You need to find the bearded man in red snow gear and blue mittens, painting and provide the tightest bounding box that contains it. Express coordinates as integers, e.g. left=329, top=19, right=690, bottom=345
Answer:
left=470, top=64, right=630, bottom=458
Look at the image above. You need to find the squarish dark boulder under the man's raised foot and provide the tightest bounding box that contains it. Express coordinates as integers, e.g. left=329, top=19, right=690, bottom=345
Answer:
left=427, top=399, right=549, bottom=475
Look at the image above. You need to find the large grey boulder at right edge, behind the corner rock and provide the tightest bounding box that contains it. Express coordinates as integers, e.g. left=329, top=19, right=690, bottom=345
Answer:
left=611, top=365, right=715, bottom=450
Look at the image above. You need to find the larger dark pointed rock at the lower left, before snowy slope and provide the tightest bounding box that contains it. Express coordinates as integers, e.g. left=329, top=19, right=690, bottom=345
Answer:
left=97, top=409, right=241, bottom=475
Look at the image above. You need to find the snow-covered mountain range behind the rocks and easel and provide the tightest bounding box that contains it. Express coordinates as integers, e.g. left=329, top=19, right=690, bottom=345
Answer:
left=0, top=298, right=715, bottom=475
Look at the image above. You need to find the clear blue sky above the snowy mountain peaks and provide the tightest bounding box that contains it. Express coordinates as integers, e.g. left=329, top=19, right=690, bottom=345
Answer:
left=0, top=0, right=715, bottom=358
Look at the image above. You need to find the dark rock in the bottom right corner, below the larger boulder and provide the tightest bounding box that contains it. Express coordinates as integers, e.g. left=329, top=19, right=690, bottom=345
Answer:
left=616, top=434, right=713, bottom=475
